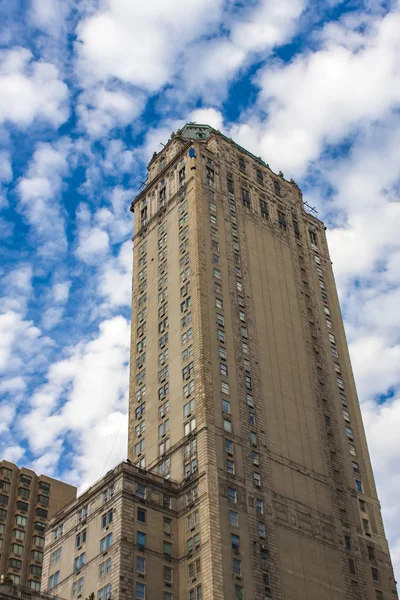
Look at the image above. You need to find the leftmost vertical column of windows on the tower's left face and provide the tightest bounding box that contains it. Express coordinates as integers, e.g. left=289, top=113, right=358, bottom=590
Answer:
left=134, top=240, right=147, bottom=469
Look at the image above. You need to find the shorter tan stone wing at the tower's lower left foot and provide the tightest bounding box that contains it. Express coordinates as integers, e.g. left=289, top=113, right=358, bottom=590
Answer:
left=42, top=462, right=200, bottom=600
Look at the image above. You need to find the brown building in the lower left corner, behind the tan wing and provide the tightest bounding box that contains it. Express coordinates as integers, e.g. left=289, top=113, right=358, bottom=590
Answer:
left=0, top=460, right=77, bottom=592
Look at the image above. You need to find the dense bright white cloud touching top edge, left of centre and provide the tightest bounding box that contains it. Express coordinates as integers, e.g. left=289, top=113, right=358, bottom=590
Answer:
left=77, top=0, right=222, bottom=92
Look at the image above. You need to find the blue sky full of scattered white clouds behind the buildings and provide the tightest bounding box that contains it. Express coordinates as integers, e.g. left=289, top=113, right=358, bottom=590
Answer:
left=0, top=0, right=400, bottom=572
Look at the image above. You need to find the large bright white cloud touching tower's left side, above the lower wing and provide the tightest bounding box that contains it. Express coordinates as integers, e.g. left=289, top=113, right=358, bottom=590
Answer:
left=20, top=316, right=130, bottom=485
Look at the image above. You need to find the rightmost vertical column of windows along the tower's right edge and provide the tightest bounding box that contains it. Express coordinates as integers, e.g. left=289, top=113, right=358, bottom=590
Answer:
left=309, top=237, right=381, bottom=598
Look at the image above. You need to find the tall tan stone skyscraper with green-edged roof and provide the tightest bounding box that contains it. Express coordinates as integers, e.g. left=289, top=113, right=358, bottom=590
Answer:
left=129, top=123, right=397, bottom=600
